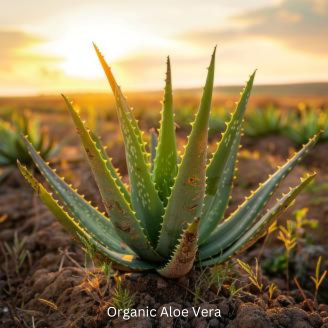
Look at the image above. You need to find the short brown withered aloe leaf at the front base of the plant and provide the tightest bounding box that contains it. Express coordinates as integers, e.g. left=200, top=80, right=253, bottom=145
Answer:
left=157, top=218, right=200, bottom=279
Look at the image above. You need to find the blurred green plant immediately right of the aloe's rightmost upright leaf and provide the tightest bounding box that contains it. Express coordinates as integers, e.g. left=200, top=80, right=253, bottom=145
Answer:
left=245, top=106, right=287, bottom=137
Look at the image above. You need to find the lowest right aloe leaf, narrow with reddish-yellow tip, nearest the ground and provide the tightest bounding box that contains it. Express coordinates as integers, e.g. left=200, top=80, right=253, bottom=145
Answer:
left=199, top=173, right=316, bottom=266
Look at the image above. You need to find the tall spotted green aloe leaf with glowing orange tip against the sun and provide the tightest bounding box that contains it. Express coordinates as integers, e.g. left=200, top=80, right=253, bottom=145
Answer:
left=96, top=44, right=164, bottom=246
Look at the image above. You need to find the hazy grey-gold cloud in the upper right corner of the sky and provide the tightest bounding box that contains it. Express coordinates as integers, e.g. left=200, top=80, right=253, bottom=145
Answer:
left=181, top=0, right=328, bottom=56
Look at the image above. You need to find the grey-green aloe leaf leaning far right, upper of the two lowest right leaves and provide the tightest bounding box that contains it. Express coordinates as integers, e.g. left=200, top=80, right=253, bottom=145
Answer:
left=199, top=134, right=320, bottom=258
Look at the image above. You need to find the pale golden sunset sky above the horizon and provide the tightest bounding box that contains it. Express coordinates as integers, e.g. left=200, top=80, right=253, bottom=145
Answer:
left=0, top=0, right=328, bottom=95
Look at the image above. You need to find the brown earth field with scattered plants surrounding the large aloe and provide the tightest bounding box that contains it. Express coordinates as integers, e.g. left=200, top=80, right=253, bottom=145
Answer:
left=0, top=83, right=328, bottom=327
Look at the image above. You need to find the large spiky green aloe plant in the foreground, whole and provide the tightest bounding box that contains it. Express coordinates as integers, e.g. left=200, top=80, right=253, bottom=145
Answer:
left=19, top=46, right=318, bottom=278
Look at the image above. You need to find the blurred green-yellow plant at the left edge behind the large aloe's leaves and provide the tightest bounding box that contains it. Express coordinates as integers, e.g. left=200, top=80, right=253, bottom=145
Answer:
left=0, top=113, right=55, bottom=178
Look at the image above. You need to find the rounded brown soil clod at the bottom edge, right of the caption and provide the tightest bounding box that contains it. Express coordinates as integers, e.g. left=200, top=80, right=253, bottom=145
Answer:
left=228, top=303, right=273, bottom=328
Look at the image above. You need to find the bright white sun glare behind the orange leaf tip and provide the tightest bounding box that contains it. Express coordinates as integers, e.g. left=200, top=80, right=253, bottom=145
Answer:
left=34, top=24, right=164, bottom=79
